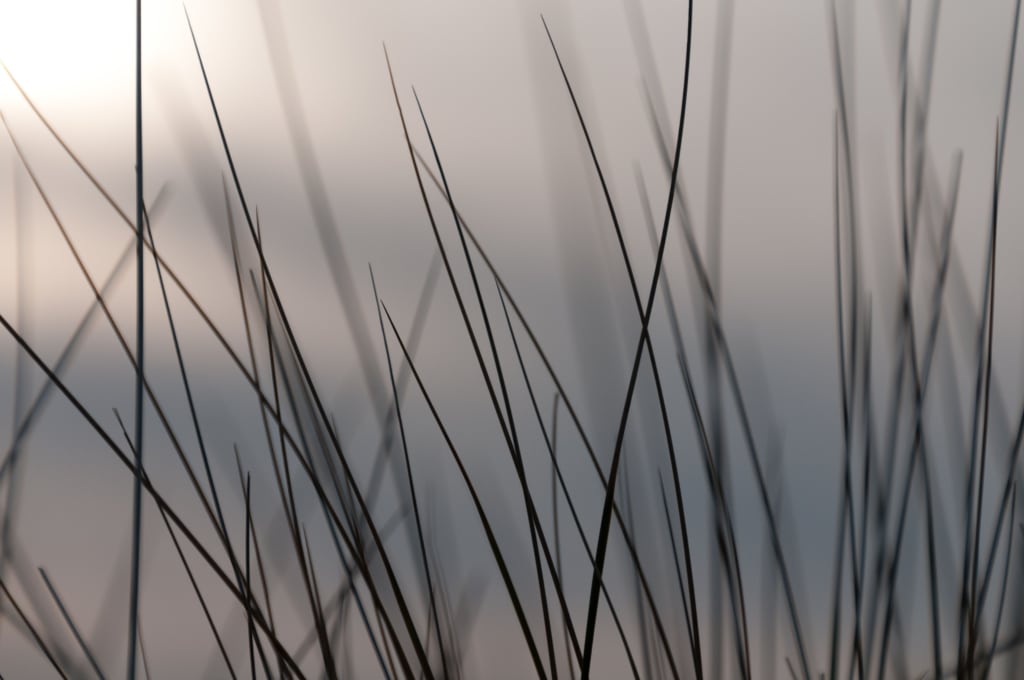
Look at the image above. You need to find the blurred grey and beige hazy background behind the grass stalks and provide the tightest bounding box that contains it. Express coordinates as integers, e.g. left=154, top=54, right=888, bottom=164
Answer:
left=0, top=0, right=1024, bottom=678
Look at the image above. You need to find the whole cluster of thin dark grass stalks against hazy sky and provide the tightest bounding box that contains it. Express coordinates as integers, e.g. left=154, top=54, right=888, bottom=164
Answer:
left=0, top=0, right=1024, bottom=680
